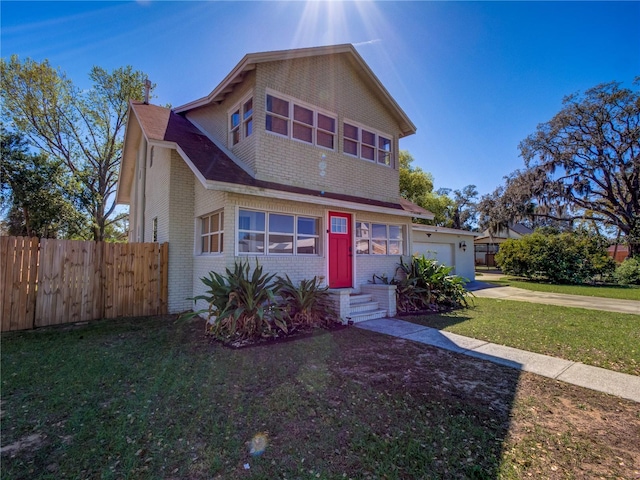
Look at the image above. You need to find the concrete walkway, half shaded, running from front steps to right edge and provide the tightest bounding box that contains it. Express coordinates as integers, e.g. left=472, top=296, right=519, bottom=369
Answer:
left=355, top=318, right=640, bottom=402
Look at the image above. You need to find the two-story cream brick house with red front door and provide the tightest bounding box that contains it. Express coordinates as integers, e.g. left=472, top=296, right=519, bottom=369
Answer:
left=117, top=45, right=433, bottom=321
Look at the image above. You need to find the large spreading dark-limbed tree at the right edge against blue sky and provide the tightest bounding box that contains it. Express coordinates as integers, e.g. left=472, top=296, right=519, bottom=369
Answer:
left=479, top=77, right=640, bottom=256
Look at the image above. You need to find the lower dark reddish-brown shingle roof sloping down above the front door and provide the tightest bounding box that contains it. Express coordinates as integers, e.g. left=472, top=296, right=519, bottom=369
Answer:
left=116, top=102, right=433, bottom=219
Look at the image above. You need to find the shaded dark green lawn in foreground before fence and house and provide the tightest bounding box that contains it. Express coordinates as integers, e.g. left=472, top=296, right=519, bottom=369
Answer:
left=2, top=319, right=508, bottom=479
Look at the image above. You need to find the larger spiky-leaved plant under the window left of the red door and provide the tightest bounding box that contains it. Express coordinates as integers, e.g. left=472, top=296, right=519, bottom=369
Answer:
left=193, top=261, right=288, bottom=343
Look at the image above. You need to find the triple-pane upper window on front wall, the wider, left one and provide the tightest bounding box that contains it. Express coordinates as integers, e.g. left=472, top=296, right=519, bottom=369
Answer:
left=265, top=93, right=337, bottom=150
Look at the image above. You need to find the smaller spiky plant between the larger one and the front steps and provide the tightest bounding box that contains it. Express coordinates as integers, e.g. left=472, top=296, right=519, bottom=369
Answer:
left=277, top=275, right=339, bottom=329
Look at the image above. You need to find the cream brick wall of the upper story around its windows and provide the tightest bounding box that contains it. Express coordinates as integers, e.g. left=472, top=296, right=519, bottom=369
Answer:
left=188, top=54, right=399, bottom=201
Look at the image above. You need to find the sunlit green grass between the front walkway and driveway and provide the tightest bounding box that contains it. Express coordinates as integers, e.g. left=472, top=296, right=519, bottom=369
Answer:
left=407, top=298, right=640, bottom=375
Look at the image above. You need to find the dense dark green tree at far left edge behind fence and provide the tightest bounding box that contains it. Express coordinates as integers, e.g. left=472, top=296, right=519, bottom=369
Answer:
left=0, top=126, right=84, bottom=238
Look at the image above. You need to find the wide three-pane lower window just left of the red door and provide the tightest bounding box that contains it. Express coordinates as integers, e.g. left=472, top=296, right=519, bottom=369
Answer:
left=238, top=210, right=320, bottom=255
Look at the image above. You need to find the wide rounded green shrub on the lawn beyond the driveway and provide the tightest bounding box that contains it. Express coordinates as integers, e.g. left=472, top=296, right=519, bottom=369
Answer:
left=496, top=229, right=615, bottom=283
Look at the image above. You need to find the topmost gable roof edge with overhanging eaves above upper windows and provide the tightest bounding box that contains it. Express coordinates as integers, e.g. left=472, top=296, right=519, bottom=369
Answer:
left=174, top=43, right=416, bottom=137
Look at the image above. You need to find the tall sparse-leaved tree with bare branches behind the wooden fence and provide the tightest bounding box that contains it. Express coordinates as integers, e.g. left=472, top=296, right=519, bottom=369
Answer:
left=0, top=55, right=151, bottom=240
